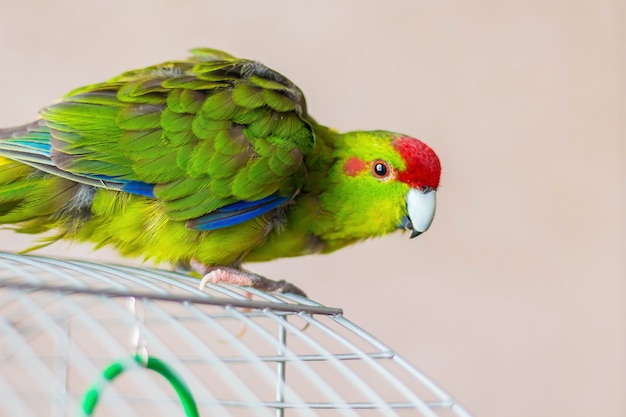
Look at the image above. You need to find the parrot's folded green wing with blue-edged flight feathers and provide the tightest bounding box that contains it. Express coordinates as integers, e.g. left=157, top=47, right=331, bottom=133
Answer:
left=0, top=49, right=314, bottom=230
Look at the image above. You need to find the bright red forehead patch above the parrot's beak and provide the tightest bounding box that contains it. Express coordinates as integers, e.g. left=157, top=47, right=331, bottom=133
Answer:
left=393, top=136, right=441, bottom=189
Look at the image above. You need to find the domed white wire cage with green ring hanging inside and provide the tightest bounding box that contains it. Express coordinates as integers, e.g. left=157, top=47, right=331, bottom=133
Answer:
left=0, top=252, right=469, bottom=417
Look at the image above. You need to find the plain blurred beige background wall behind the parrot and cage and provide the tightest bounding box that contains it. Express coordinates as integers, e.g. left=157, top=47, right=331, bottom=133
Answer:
left=0, top=0, right=626, bottom=417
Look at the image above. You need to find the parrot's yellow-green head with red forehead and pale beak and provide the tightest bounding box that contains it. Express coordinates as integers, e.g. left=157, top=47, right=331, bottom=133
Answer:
left=316, top=131, right=441, bottom=238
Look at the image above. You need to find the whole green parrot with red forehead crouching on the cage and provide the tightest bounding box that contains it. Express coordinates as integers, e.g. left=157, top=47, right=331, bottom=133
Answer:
left=0, top=48, right=441, bottom=295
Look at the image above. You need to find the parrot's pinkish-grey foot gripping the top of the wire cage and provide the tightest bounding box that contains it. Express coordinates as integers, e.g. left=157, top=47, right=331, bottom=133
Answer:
left=191, top=261, right=306, bottom=297
